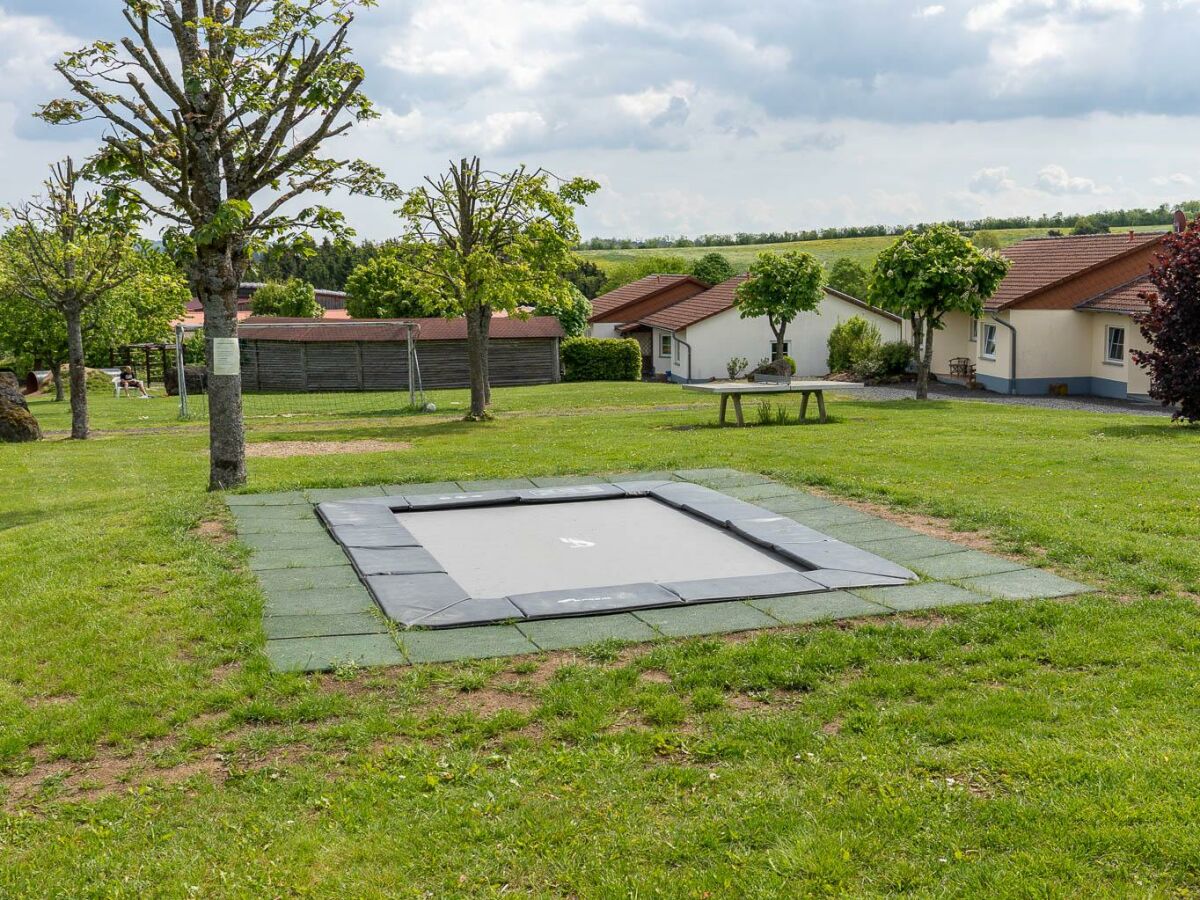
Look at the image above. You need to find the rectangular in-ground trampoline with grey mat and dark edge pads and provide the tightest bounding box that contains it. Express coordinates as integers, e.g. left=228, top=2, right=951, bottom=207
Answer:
left=317, top=481, right=917, bottom=629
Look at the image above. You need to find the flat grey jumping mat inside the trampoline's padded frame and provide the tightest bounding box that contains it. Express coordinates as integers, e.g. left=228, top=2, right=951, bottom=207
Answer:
left=396, top=497, right=799, bottom=596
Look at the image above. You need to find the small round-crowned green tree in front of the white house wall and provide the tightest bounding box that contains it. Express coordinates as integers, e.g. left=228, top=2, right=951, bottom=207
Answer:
left=733, top=250, right=824, bottom=360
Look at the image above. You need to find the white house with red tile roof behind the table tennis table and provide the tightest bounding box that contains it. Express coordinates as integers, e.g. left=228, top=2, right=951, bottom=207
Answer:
left=590, top=275, right=902, bottom=382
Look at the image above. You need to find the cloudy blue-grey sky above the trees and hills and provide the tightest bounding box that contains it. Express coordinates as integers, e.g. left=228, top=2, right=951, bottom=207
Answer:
left=0, top=0, right=1200, bottom=238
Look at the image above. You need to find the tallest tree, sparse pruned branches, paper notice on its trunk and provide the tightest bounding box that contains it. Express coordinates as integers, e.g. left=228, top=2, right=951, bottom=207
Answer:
left=38, top=0, right=389, bottom=490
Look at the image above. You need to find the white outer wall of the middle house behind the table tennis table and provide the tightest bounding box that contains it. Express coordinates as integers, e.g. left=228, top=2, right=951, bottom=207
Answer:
left=654, top=294, right=901, bottom=380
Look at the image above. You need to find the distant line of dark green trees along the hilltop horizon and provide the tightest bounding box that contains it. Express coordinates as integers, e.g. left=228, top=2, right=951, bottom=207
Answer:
left=580, top=200, right=1200, bottom=250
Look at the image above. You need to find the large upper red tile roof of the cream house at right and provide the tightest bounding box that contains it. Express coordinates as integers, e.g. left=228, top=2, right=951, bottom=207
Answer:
left=986, top=233, right=1163, bottom=310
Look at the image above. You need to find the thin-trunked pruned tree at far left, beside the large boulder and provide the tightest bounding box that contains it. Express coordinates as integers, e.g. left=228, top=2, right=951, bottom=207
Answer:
left=0, top=157, right=142, bottom=440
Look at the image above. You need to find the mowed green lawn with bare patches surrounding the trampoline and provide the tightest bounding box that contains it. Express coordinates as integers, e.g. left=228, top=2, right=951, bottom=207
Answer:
left=0, top=384, right=1200, bottom=898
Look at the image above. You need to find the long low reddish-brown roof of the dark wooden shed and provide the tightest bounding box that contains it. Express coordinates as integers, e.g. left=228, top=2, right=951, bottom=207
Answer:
left=239, top=316, right=564, bottom=342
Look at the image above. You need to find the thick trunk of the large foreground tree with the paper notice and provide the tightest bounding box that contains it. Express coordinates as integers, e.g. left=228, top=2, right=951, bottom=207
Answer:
left=192, top=247, right=246, bottom=491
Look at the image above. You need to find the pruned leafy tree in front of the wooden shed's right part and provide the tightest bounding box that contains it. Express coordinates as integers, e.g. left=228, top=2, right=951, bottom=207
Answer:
left=400, top=157, right=600, bottom=420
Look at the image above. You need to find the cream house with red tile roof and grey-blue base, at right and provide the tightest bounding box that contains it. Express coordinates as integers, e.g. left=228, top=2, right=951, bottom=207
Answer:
left=934, top=232, right=1164, bottom=398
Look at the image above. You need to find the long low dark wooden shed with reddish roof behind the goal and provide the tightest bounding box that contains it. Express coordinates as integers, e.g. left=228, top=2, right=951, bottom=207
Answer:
left=239, top=316, right=563, bottom=392
